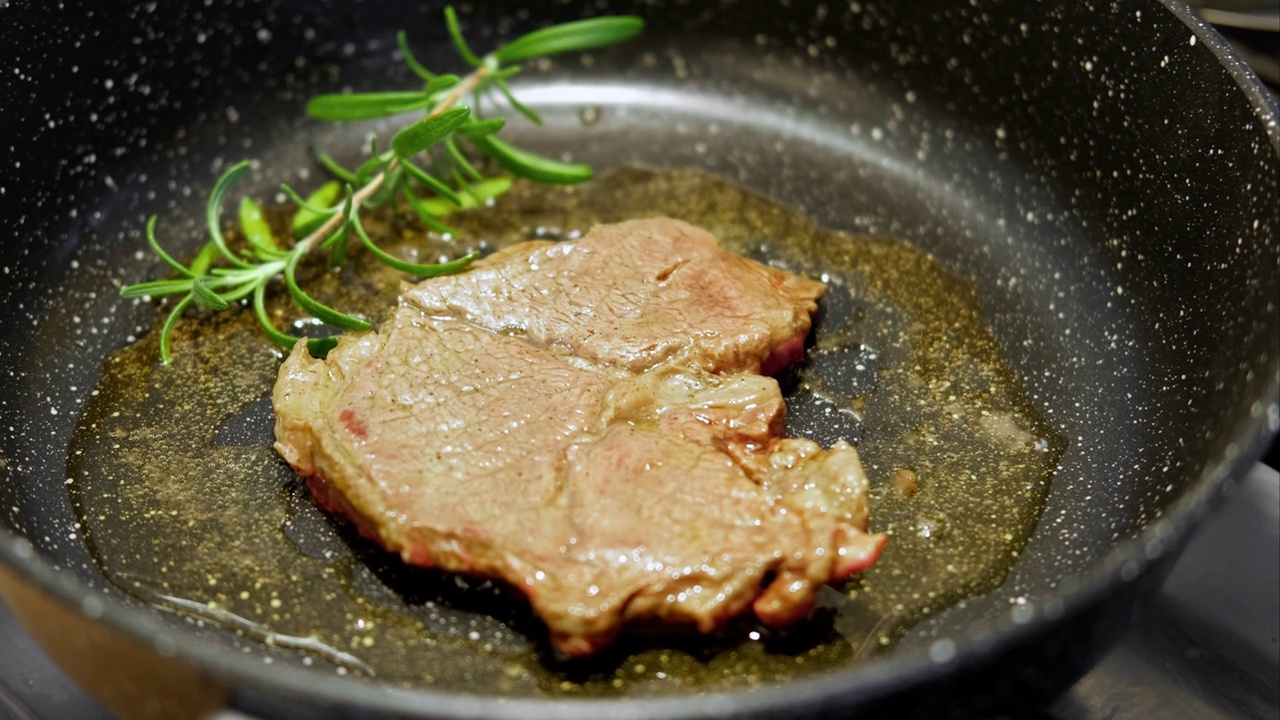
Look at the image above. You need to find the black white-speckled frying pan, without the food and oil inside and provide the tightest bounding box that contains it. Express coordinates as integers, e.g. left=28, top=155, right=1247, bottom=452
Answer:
left=0, top=0, right=1280, bottom=717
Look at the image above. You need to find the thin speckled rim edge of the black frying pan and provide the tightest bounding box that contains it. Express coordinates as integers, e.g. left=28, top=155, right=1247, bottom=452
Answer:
left=0, top=0, right=1280, bottom=719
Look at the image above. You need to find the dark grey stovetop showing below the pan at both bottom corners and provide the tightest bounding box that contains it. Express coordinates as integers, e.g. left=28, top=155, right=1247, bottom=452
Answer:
left=0, top=464, right=1280, bottom=720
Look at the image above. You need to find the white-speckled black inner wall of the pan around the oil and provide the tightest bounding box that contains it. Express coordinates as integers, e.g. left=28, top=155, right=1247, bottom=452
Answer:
left=0, top=3, right=1280, bottom=707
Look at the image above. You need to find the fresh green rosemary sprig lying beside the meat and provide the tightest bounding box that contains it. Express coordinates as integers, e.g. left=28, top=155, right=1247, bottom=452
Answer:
left=120, top=8, right=644, bottom=364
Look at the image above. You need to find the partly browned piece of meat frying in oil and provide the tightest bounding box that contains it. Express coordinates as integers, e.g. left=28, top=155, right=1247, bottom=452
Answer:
left=274, top=219, right=886, bottom=656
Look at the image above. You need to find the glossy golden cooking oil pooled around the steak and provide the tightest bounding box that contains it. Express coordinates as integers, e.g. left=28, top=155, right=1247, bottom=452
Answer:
left=68, top=170, right=1062, bottom=696
